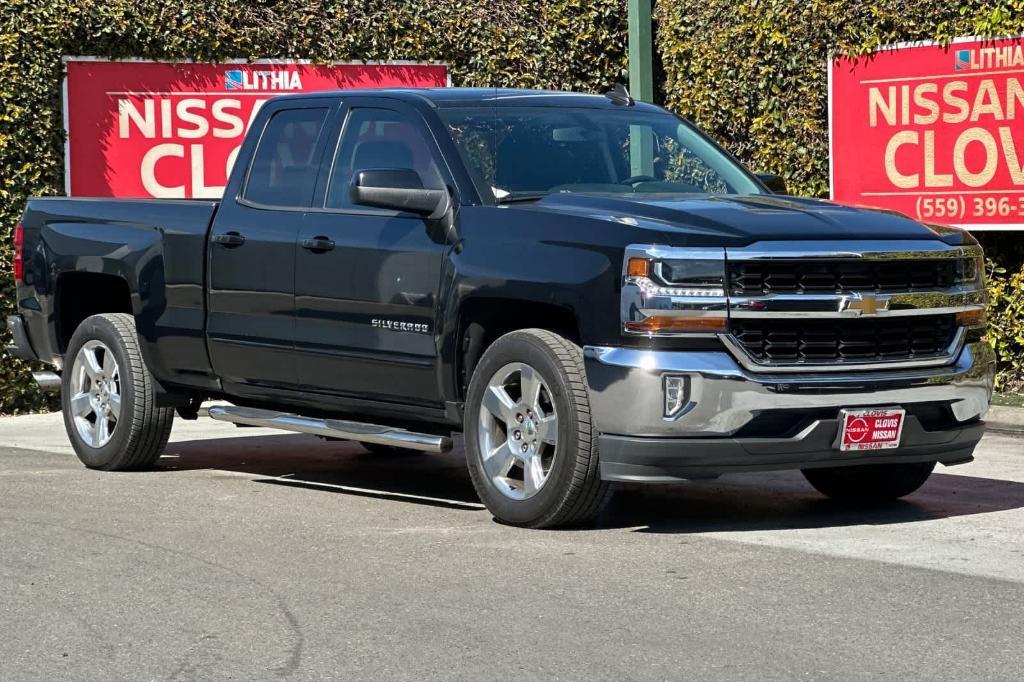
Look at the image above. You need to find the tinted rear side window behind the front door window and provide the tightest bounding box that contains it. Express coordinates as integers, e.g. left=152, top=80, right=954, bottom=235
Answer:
left=242, top=109, right=328, bottom=208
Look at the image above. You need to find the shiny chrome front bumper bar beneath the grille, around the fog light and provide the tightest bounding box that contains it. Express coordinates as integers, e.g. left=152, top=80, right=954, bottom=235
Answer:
left=584, top=343, right=995, bottom=437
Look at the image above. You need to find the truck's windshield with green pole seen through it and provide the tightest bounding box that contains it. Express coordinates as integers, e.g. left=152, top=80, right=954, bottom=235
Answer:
left=441, top=106, right=763, bottom=202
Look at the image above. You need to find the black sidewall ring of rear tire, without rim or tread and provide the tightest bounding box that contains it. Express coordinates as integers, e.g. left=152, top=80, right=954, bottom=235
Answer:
left=60, top=315, right=142, bottom=469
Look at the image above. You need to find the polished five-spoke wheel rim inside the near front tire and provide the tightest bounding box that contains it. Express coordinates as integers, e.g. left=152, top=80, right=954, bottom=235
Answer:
left=478, top=363, right=558, bottom=500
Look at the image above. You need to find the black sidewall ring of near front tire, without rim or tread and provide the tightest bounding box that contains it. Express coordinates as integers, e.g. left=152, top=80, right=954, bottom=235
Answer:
left=464, top=332, right=580, bottom=524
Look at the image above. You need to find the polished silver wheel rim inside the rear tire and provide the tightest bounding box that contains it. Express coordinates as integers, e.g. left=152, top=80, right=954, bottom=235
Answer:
left=70, top=340, right=121, bottom=447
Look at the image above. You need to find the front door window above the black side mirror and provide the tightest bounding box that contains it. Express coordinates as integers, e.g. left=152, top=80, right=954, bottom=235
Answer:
left=327, top=109, right=444, bottom=209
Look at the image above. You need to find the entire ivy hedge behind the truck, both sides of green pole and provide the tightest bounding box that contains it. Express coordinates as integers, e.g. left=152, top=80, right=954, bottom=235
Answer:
left=0, top=0, right=1024, bottom=414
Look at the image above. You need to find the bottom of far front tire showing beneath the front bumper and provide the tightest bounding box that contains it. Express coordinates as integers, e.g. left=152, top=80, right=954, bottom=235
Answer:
left=803, top=462, right=935, bottom=503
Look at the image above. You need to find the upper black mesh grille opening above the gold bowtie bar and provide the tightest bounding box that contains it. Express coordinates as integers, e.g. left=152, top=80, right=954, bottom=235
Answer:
left=727, top=258, right=977, bottom=296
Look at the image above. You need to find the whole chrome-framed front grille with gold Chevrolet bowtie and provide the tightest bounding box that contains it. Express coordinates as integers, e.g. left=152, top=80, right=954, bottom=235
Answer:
left=720, top=241, right=985, bottom=373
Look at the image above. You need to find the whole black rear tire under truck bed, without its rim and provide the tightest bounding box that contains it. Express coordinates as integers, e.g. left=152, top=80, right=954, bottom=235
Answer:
left=60, top=313, right=174, bottom=471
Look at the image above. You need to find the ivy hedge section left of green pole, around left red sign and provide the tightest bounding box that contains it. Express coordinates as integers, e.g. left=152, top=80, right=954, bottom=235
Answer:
left=0, top=0, right=626, bottom=414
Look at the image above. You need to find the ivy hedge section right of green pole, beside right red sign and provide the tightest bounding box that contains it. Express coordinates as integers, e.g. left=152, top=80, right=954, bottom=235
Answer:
left=654, top=0, right=1024, bottom=197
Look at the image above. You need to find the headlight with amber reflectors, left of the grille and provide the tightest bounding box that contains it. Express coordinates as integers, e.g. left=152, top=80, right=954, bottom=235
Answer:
left=622, top=247, right=728, bottom=336
